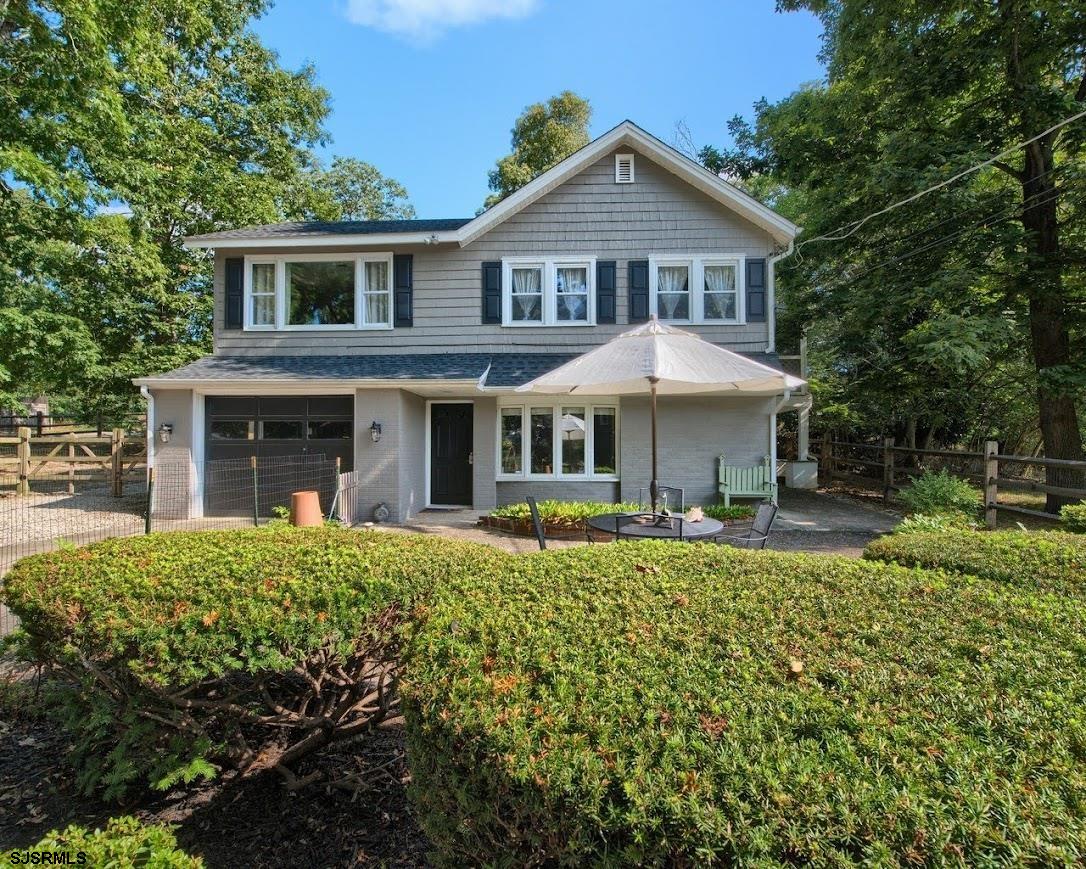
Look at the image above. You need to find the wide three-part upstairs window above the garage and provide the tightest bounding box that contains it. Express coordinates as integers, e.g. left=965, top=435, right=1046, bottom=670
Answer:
left=244, top=253, right=392, bottom=330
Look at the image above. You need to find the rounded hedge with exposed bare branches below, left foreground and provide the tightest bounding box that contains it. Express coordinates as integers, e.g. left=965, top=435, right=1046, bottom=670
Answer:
left=3, top=526, right=507, bottom=798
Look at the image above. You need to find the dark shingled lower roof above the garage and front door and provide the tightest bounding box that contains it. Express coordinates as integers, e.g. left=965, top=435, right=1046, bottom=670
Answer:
left=150, top=353, right=781, bottom=389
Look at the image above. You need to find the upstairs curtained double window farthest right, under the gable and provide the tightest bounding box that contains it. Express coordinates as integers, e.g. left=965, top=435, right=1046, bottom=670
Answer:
left=648, top=255, right=746, bottom=325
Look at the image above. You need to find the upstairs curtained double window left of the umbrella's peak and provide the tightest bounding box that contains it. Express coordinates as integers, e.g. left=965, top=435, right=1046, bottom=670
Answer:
left=502, top=256, right=596, bottom=326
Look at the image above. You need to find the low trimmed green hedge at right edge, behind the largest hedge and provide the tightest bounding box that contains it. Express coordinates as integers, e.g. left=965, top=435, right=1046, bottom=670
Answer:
left=863, top=530, right=1086, bottom=595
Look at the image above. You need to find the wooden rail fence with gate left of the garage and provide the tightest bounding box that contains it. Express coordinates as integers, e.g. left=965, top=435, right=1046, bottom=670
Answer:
left=0, top=427, right=147, bottom=498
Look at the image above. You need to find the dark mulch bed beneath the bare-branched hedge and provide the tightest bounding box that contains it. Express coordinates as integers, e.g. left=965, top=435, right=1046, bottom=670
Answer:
left=0, top=690, right=429, bottom=867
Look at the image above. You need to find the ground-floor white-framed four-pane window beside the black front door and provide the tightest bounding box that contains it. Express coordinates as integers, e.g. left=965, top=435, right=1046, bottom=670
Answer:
left=496, top=399, right=619, bottom=480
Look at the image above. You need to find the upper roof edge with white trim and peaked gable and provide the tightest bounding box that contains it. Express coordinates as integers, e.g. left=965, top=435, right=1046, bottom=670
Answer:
left=185, top=121, right=800, bottom=248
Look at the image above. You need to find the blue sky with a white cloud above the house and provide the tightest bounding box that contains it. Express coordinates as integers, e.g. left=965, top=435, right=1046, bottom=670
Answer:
left=249, top=0, right=823, bottom=217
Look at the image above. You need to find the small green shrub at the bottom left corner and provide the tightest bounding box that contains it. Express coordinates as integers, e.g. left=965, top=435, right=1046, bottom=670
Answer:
left=3, top=817, right=203, bottom=869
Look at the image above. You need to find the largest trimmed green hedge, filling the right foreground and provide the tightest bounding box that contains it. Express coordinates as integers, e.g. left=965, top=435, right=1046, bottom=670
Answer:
left=405, top=542, right=1086, bottom=866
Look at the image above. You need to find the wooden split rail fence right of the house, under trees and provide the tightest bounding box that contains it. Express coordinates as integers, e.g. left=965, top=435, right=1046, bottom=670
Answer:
left=811, top=438, right=1086, bottom=528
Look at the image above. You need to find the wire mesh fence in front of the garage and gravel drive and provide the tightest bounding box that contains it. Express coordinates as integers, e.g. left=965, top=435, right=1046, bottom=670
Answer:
left=0, top=454, right=341, bottom=637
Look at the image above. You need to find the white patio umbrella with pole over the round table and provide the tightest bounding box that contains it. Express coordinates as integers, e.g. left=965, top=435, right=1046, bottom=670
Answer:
left=517, top=317, right=806, bottom=511
